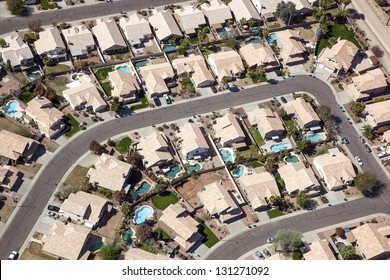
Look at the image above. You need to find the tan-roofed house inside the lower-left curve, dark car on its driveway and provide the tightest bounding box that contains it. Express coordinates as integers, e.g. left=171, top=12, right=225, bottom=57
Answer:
left=59, top=191, right=108, bottom=228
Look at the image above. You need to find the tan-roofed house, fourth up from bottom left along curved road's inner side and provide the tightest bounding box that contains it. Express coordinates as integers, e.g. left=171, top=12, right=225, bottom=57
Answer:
left=137, top=131, right=173, bottom=170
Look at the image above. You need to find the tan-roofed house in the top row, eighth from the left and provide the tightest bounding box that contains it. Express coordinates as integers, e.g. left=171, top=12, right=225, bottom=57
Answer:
left=200, top=0, right=233, bottom=30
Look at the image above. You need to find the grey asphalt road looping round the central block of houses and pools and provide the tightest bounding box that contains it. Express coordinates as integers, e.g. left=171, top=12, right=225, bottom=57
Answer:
left=0, top=76, right=390, bottom=259
